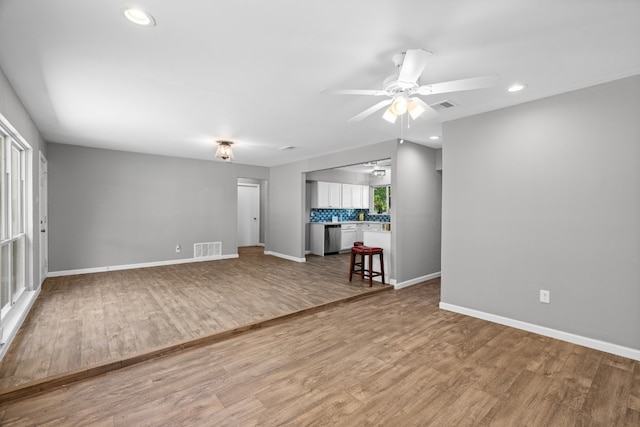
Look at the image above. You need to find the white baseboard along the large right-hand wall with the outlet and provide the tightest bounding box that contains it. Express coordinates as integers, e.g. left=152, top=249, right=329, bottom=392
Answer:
left=440, top=302, right=640, bottom=361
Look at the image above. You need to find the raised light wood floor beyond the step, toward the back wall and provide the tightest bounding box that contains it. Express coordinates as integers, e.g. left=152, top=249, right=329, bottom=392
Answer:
left=0, top=247, right=390, bottom=402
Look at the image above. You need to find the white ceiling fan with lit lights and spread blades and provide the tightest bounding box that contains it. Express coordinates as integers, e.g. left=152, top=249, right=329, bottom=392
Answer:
left=320, top=49, right=498, bottom=123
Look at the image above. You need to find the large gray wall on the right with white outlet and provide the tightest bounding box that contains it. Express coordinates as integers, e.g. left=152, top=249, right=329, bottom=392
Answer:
left=441, top=76, right=640, bottom=349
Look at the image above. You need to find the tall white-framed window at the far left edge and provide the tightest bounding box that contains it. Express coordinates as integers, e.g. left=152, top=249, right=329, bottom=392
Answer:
left=0, top=135, right=26, bottom=318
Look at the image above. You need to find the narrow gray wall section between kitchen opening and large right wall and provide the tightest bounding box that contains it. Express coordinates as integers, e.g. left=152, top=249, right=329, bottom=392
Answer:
left=391, top=142, right=442, bottom=282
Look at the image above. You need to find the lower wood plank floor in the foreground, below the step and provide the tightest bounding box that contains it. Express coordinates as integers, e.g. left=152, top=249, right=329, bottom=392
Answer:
left=0, top=279, right=640, bottom=426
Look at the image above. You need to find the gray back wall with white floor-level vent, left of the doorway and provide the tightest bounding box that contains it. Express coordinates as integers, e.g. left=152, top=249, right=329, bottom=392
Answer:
left=49, top=144, right=268, bottom=271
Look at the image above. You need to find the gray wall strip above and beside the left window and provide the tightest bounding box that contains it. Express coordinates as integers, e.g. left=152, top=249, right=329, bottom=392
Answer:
left=0, top=70, right=47, bottom=289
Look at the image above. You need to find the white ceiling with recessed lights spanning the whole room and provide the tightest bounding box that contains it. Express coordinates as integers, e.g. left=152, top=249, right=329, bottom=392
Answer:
left=0, top=0, right=640, bottom=166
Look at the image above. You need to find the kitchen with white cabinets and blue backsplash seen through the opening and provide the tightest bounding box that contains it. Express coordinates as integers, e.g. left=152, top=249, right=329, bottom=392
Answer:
left=306, top=160, right=392, bottom=283
